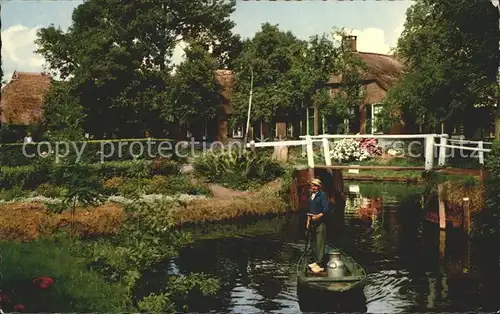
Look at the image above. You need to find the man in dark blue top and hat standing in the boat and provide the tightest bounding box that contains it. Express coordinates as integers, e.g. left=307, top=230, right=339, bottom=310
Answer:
left=306, top=179, right=329, bottom=273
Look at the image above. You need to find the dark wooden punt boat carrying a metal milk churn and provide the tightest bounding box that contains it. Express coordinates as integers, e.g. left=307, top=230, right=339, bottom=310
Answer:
left=297, top=246, right=367, bottom=312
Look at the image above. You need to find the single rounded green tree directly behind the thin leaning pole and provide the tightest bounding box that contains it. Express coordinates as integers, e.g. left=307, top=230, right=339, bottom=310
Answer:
left=229, top=23, right=305, bottom=126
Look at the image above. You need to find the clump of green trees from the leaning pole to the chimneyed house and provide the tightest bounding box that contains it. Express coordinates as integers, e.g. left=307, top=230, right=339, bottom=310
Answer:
left=230, top=23, right=357, bottom=132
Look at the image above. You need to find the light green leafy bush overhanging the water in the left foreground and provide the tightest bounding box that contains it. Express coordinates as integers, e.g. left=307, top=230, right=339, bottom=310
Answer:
left=89, top=202, right=219, bottom=313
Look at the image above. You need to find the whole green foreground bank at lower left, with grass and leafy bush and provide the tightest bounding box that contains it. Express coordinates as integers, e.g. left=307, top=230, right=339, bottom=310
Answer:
left=0, top=201, right=218, bottom=313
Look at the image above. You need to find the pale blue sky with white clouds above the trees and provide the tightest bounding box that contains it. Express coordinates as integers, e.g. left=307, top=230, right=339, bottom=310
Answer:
left=1, top=0, right=412, bottom=82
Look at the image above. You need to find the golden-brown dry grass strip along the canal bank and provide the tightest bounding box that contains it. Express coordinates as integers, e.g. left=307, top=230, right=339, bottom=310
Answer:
left=0, top=181, right=289, bottom=241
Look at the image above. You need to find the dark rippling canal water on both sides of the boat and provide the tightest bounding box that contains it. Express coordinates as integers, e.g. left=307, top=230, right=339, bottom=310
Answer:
left=168, top=183, right=500, bottom=313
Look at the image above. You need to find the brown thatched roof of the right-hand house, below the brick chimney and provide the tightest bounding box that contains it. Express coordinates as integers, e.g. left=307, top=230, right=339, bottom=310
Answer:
left=327, top=52, right=404, bottom=91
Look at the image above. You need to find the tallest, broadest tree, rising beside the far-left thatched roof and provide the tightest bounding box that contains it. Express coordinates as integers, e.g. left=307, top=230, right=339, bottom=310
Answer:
left=37, top=0, right=237, bottom=137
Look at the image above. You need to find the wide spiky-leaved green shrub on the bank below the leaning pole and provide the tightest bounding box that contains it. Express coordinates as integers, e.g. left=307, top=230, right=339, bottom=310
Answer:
left=194, top=151, right=285, bottom=189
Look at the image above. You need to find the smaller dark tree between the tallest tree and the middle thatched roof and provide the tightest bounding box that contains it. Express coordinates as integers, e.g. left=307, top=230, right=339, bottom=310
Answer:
left=163, top=43, right=221, bottom=138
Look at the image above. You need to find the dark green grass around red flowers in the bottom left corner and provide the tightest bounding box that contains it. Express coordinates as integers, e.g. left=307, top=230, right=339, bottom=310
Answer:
left=0, top=240, right=130, bottom=313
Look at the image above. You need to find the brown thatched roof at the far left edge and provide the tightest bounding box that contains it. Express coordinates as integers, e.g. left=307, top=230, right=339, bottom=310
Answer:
left=0, top=71, right=52, bottom=125
